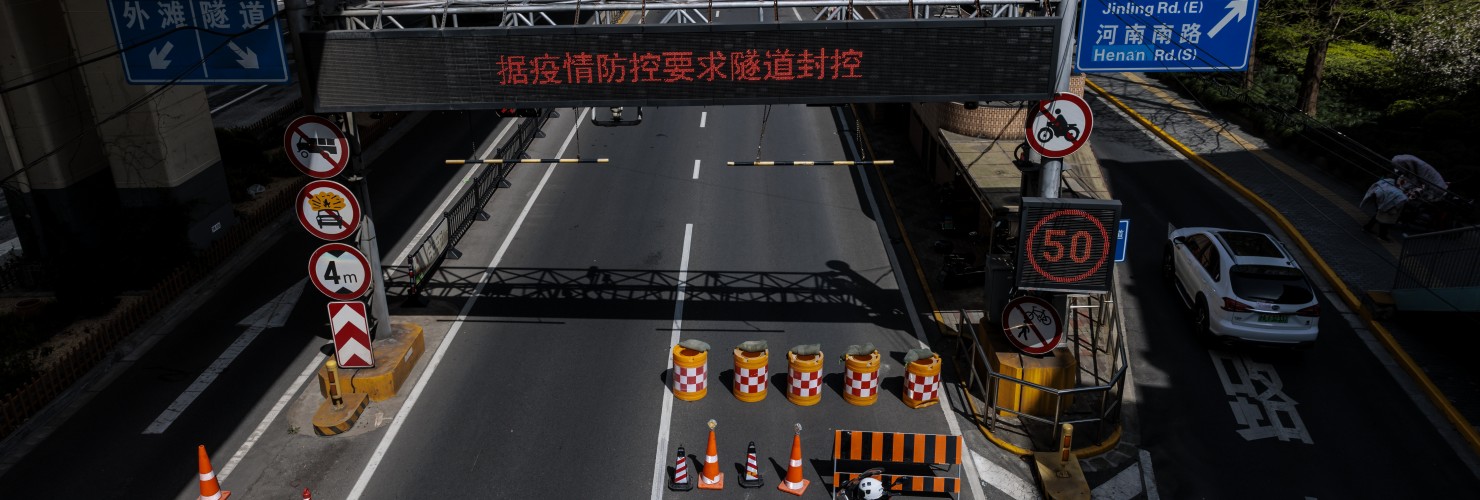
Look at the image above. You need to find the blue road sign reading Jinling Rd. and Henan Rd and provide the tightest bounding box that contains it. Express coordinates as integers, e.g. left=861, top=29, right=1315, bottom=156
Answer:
left=1074, top=0, right=1259, bottom=72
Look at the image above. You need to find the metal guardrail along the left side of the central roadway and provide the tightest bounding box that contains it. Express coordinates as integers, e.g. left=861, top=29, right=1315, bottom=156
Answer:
left=386, top=108, right=555, bottom=297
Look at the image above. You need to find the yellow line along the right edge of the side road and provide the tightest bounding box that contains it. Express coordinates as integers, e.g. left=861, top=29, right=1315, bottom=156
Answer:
left=1085, top=78, right=1480, bottom=461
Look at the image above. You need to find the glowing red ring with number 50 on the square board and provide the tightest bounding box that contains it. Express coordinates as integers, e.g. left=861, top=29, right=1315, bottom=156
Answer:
left=1026, top=209, right=1113, bottom=283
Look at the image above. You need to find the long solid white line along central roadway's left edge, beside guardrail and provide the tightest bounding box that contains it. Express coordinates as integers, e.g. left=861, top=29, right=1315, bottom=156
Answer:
left=348, top=108, right=591, bottom=500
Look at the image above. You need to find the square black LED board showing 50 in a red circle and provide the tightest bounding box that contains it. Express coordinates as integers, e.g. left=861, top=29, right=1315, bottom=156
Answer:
left=1017, top=198, right=1120, bottom=293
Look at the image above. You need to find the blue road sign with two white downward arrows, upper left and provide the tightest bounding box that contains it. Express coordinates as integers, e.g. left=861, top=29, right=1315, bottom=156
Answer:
left=108, top=0, right=289, bottom=84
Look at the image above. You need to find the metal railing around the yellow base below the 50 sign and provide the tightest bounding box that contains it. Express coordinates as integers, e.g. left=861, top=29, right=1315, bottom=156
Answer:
left=956, top=288, right=1128, bottom=442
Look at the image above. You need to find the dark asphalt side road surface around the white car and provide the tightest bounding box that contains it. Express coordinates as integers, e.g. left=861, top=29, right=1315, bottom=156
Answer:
left=1091, top=91, right=1480, bottom=499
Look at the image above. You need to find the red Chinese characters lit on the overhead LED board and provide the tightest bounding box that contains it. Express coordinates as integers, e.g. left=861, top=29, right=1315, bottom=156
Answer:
left=497, top=47, right=863, bottom=86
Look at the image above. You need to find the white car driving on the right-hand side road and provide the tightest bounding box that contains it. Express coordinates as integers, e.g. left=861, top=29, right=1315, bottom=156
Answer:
left=1162, top=228, right=1320, bottom=346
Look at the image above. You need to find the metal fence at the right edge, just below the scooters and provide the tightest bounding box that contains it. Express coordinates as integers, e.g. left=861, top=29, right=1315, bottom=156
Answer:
left=1393, top=226, right=1480, bottom=290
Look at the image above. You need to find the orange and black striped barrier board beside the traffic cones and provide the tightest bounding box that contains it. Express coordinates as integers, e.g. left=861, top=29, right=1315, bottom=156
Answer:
left=833, top=429, right=963, bottom=497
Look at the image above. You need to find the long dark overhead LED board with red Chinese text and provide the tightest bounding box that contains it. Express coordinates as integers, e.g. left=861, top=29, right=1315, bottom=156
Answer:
left=303, top=18, right=1058, bottom=112
